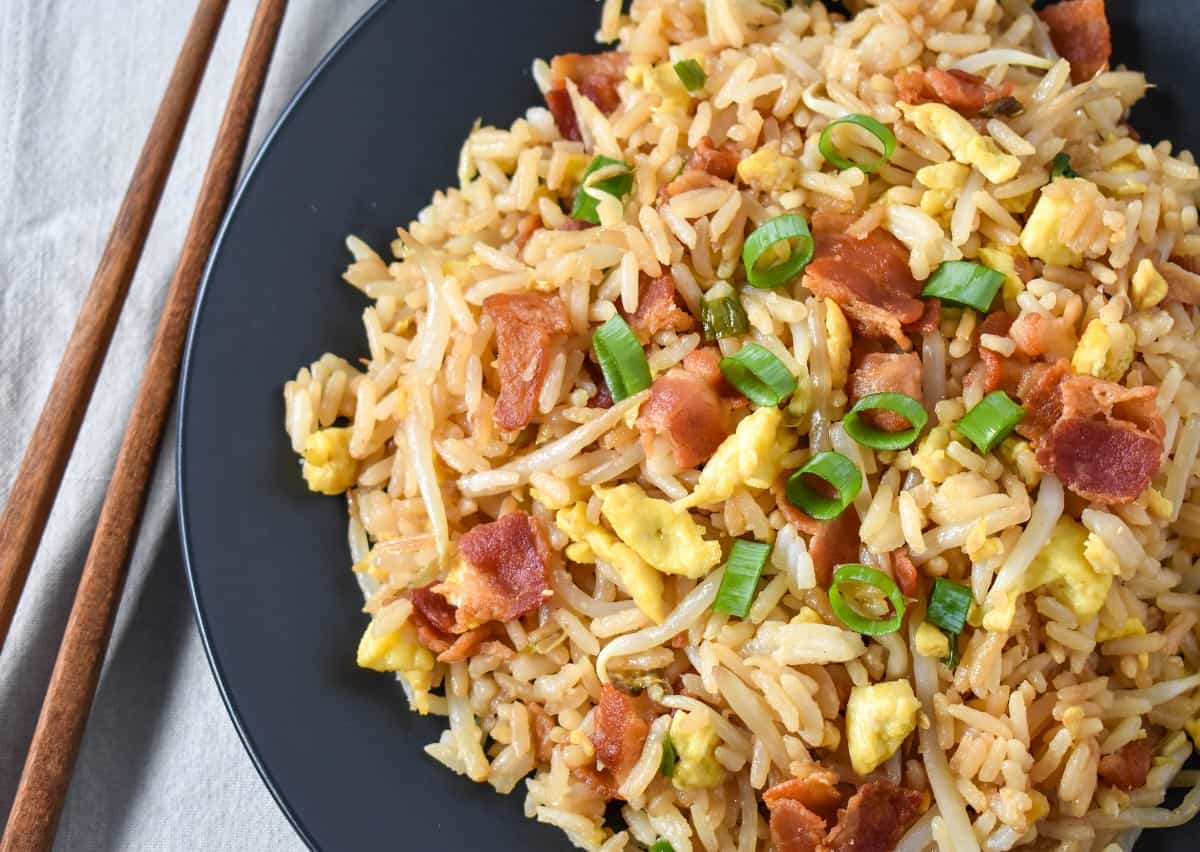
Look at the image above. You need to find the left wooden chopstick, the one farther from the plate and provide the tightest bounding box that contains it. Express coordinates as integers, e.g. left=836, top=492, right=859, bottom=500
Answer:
left=0, top=0, right=229, bottom=649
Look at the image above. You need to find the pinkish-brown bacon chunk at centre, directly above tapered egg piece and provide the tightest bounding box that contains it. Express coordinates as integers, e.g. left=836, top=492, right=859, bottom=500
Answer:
left=637, top=348, right=744, bottom=470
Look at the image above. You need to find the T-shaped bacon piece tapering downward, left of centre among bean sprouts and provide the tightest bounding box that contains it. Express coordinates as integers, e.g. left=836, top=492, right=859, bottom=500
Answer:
left=484, top=293, right=571, bottom=431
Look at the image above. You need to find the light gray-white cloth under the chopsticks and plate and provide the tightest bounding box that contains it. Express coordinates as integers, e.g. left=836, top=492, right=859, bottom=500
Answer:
left=0, top=0, right=371, bottom=852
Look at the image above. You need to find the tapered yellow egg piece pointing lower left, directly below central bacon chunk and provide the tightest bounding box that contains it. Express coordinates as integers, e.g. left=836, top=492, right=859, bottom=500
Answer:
left=674, top=408, right=796, bottom=509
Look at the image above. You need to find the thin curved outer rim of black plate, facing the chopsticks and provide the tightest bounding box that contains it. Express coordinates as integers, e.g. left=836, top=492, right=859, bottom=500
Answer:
left=173, top=0, right=391, bottom=852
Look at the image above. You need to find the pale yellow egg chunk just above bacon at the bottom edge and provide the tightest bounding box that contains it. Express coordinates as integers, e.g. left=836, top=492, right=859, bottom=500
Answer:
left=846, top=680, right=920, bottom=775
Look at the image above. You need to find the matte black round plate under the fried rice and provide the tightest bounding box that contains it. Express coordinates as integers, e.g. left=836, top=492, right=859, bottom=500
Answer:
left=178, top=0, right=1200, bottom=852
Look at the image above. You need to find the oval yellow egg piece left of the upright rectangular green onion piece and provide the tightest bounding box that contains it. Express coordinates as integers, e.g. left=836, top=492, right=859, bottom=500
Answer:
left=596, top=482, right=721, bottom=580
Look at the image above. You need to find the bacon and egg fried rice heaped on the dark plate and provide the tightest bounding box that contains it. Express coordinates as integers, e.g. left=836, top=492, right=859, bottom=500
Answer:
left=284, top=0, right=1200, bottom=852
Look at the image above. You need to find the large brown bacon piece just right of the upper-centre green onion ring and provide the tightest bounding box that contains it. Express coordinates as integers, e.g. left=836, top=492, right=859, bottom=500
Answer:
left=804, top=214, right=925, bottom=352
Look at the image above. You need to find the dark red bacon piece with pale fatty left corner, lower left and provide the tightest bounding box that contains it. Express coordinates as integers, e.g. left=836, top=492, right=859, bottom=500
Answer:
left=433, top=511, right=551, bottom=632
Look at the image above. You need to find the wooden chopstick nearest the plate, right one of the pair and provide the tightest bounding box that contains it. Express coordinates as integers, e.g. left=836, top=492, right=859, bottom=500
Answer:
left=0, top=0, right=287, bottom=852
